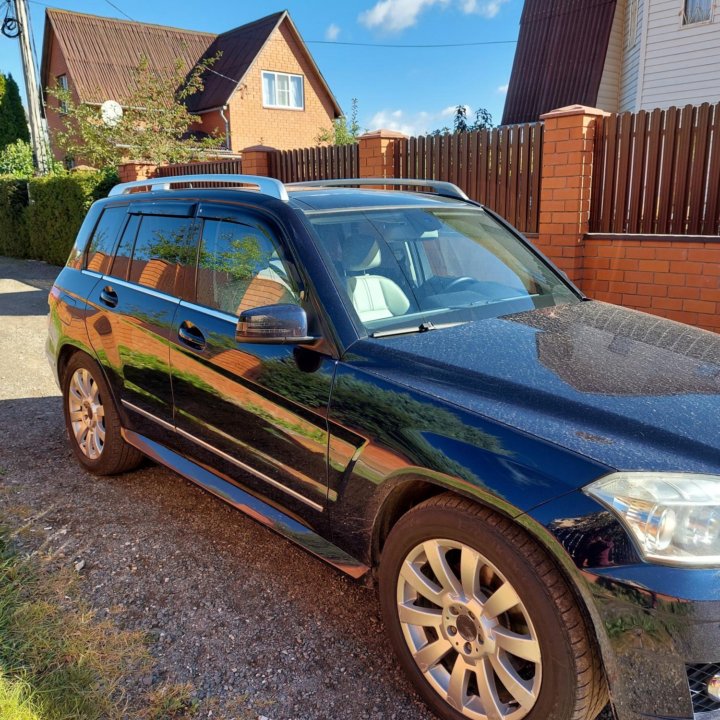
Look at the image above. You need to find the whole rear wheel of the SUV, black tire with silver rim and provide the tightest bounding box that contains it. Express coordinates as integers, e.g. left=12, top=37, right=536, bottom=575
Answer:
left=62, top=352, right=143, bottom=475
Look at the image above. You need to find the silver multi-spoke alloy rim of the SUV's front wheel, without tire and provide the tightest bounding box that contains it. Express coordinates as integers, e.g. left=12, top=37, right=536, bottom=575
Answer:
left=397, top=539, right=542, bottom=720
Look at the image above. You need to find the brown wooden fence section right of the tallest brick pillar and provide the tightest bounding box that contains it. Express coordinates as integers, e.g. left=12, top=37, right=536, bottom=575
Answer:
left=590, top=103, right=720, bottom=235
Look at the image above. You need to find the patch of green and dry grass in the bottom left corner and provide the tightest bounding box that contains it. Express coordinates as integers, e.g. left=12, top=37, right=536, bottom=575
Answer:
left=0, top=528, right=150, bottom=720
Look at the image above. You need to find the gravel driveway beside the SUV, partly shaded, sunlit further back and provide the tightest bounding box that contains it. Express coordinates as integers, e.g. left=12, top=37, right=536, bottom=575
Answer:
left=0, top=258, right=610, bottom=720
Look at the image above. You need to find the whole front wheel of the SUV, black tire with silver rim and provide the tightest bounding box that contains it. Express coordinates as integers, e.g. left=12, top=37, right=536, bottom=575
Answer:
left=379, top=494, right=607, bottom=720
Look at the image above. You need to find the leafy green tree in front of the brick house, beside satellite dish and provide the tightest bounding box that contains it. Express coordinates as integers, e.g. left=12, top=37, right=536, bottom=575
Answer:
left=48, top=56, right=222, bottom=168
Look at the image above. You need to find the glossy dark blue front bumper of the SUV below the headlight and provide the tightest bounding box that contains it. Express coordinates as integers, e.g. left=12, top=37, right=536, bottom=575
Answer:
left=583, top=564, right=720, bottom=720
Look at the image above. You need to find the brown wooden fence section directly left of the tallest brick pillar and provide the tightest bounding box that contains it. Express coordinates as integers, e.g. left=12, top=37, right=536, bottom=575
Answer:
left=395, top=123, right=543, bottom=233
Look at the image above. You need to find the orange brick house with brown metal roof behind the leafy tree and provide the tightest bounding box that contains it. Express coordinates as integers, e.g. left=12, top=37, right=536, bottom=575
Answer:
left=41, top=8, right=342, bottom=152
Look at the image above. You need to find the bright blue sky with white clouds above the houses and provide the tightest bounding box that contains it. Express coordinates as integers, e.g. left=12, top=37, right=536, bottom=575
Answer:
left=0, top=0, right=523, bottom=135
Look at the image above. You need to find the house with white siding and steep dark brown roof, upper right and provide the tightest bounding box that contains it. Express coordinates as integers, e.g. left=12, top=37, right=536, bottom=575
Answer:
left=503, top=0, right=720, bottom=125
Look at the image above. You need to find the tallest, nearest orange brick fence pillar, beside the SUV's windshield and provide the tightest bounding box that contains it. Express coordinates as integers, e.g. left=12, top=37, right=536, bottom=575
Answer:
left=537, top=105, right=609, bottom=283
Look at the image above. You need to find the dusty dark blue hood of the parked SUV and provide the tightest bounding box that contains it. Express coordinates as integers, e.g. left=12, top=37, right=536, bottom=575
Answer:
left=352, top=301, right=720, bottom=473
